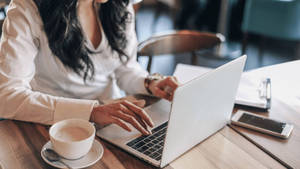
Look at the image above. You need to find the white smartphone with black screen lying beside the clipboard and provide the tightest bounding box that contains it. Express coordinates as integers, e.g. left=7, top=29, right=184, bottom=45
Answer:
left=231, top=110, right=294, bottom=138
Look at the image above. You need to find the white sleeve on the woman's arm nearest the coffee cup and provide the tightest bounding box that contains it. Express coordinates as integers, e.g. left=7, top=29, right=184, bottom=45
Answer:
left=0, top=0, right=96, bottom=124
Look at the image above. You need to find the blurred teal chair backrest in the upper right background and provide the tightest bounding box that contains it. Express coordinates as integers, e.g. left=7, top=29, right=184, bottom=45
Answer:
left=242, top=0, right=300, bottom=40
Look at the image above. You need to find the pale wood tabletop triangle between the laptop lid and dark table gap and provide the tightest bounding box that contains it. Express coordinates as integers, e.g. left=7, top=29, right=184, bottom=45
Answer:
left=170, top=127, right=284, bottom=169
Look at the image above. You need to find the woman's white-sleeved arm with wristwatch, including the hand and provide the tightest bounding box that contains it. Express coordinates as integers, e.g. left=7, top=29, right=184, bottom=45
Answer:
left=115, top=2, right=179, bottom=101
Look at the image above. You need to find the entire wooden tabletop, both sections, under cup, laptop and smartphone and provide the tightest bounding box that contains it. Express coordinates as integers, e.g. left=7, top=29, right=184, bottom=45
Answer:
left=0, top=61, right=300, bottom=169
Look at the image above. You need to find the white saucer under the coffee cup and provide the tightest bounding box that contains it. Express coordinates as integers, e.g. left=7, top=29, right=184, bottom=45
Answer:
left=41, top=140, right=104, bottom=169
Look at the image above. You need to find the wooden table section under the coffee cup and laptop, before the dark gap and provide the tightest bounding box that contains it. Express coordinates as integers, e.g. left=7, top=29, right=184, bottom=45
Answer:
left=0, top=120, right=284, bottom=169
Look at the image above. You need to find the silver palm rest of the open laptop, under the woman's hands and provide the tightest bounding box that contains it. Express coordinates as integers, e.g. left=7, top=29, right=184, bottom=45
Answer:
left=97, top=99, right=171, bottom=144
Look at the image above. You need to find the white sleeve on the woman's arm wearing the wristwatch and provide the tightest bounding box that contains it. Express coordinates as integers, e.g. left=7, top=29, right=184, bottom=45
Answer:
left=115, top=4, right=148, bottom=94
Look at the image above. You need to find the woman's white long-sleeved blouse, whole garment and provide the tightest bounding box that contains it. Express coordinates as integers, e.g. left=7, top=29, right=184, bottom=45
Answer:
left=0, top=0, right=147, bottom=124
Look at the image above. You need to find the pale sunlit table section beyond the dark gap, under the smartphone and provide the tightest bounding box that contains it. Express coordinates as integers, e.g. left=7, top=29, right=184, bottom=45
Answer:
left=233, top=61, right=300, bottom=168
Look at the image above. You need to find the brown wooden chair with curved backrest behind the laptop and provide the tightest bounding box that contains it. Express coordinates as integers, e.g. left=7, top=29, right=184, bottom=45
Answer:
left=137, top=30, right=225, bottom=72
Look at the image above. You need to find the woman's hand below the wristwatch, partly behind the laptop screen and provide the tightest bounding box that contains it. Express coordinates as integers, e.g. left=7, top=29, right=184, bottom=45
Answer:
left=149, top=76, right=179, bottom=101
